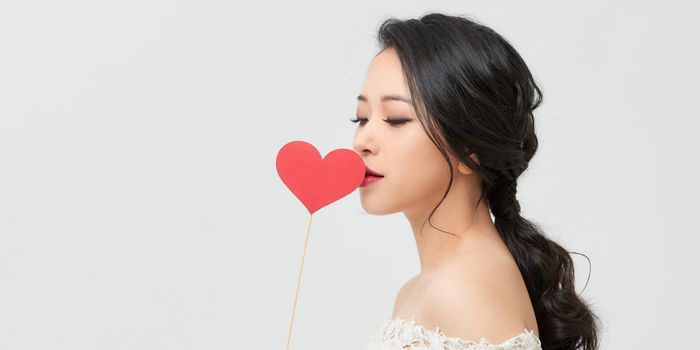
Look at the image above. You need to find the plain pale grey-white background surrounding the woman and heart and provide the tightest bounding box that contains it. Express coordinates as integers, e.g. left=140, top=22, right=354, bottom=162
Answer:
left=0, top=1, right=700, bottom=350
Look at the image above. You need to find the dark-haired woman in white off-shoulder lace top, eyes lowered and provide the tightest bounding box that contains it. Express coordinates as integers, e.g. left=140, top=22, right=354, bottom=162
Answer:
left=352, top=13, right=598, bottom=350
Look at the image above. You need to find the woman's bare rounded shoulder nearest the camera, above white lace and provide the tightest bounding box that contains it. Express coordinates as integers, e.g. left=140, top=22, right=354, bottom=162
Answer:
left=422, top=252, right=538, bottom=344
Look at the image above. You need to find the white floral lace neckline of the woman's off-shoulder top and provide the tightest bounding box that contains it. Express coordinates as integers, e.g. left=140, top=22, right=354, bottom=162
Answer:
left=367, top=318, right=542, bottom=350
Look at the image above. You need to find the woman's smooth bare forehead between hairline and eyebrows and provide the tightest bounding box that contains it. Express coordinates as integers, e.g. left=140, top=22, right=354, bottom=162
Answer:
left=362, top=48, right=409, bottom=103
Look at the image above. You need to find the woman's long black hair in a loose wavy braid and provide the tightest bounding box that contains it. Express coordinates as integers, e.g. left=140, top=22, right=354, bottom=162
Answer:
left=377, top=13, right=599, bottom=350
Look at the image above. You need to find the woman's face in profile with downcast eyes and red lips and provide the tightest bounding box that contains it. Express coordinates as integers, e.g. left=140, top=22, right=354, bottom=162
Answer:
left=353, top=48, right=456, bottom=215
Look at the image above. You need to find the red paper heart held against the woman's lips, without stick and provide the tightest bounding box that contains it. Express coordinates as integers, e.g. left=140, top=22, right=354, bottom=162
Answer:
left=277, top=141, right=365, bottom=214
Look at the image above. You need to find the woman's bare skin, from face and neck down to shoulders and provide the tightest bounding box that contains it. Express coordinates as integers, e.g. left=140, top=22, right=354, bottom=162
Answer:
left=353, top=48, right=539, bottom=343
